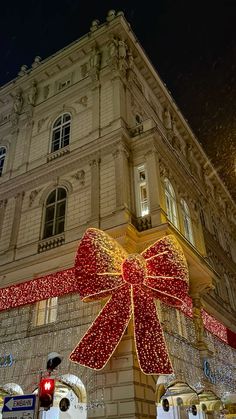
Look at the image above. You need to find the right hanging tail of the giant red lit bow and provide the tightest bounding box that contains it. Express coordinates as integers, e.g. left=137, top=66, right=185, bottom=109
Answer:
left=132, top=285, right=173, bottom=374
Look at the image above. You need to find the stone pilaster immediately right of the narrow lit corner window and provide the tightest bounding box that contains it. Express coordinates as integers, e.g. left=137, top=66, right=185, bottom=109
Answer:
left=145, top=149, right=161, bottom=227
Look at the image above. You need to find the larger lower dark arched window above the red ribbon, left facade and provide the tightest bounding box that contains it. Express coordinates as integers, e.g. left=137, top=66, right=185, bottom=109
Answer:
left=43, top=188, right=66, bottom=239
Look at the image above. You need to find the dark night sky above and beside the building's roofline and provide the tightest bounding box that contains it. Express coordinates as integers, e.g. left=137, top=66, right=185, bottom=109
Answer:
left=0, top=0, right=236, bottom=199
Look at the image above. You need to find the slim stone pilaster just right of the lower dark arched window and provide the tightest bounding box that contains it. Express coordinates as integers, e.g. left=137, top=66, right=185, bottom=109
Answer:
left=90, top=158, right=100, bottom=228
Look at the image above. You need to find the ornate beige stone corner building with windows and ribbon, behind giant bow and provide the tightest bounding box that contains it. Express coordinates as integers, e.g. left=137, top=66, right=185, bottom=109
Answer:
left=0, top=11, right=236, bottom=419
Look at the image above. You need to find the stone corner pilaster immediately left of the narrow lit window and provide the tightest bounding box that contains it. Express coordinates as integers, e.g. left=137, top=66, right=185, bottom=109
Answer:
left=113, top=143, right=130, bottom=211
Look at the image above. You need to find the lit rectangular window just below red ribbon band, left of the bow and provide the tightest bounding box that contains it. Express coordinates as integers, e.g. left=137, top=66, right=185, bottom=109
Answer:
left=34, top=297, right=58, bottom=326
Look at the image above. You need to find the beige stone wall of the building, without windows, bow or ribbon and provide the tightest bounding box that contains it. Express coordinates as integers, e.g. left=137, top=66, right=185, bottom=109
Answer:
left=0, top=9, right=236, bottom=418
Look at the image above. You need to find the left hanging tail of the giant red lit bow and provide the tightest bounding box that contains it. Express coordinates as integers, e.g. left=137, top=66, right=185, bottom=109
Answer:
left=70, top=284, right=132, bottom=370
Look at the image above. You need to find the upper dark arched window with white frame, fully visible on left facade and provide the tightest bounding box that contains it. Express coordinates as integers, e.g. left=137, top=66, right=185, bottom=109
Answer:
left=51, top=113, right=71, bottom=153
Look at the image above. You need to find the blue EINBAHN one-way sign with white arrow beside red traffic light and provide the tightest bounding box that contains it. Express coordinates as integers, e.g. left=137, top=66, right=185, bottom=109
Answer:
left=2, top=394, right=36, bottom=417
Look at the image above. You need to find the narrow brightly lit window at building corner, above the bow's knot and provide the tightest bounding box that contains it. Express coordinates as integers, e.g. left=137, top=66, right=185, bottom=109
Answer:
left=136, top=165, right=149, bottom=217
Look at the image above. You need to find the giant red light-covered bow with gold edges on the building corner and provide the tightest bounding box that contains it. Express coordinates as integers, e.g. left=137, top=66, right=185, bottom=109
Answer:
left=70, top=228, right=188, bottom=374
